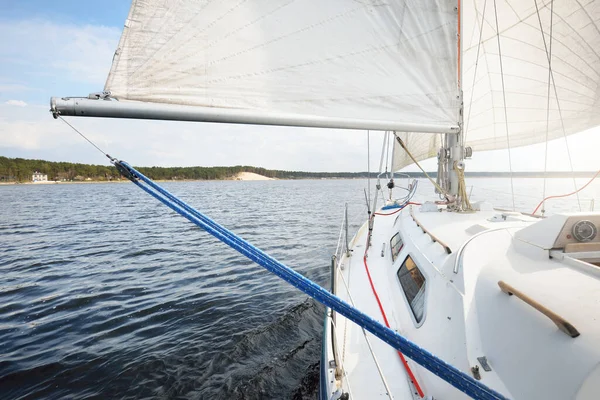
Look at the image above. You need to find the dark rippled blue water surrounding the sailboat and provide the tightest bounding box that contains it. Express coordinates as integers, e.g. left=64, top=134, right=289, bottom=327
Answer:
left=0, top=179, right=600, bottom=399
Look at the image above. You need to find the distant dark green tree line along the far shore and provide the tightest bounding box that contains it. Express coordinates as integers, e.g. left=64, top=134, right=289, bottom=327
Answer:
left=0, top=156, right=374, bottom=182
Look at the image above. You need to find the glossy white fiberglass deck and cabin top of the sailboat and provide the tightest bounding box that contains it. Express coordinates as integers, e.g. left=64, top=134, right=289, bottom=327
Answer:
left=330, top=206, right=600, bottom=400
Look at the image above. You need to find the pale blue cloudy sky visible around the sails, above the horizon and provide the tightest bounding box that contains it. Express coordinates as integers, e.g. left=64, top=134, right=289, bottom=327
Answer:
left=0, top=0, right=600, bottom=171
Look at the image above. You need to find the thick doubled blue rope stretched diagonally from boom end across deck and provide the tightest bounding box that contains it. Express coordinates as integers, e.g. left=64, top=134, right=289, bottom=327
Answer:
left=113, top=160, right=506, bottom=400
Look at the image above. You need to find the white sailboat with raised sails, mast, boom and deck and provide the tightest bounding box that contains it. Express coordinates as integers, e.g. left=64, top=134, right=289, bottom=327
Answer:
left=51, top=0, right=600, bottom=400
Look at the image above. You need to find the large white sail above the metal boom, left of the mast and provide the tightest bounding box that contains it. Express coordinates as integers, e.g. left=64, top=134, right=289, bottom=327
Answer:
left=105, top=0, right=460, bottom=126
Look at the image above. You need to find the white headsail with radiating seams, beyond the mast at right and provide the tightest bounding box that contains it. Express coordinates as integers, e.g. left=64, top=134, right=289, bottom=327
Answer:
left=394, top=0, right=600, bottom=169
